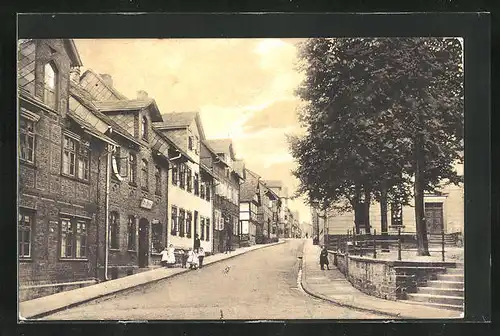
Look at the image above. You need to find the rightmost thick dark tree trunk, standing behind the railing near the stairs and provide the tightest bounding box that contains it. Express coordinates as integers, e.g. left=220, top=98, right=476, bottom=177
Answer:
left=414, top=134, right=430, bottom=256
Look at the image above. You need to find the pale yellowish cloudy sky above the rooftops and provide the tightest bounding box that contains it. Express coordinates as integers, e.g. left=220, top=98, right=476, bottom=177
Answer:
left=75, top=39, right=310, bottom=222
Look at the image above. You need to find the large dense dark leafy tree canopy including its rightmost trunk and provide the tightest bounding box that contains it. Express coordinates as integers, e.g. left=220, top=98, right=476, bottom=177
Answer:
left=291, top=38, right=463, bottom=255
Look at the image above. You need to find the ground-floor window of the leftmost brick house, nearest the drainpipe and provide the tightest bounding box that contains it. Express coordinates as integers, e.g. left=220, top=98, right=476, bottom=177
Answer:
left=60, top=218, right=87, bottom=259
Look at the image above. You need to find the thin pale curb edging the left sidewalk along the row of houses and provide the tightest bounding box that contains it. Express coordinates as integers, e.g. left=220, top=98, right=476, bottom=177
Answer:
left=23, top=240, right=286, bottom=323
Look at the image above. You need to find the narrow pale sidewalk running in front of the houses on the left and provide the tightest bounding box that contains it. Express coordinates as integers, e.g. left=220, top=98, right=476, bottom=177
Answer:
left=19, top=241, right=285, bottom=319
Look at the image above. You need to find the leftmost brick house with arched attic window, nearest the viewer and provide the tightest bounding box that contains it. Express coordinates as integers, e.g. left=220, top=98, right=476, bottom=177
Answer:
left=18, top=39, right=112, bottom=300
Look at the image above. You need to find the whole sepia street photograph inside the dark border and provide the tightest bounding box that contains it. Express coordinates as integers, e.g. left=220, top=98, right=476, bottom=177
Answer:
left=17, top=36, right=466, bottom=321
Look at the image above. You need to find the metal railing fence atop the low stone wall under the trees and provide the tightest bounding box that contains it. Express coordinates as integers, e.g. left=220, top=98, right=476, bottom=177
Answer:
left=325, top=228, right=462, bottom=262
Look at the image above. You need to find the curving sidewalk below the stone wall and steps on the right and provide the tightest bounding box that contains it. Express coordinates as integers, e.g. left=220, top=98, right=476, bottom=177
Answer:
left=301, top=239, right=461, bottom=319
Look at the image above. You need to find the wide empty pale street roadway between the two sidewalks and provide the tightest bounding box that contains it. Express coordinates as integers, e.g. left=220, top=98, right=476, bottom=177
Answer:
left=43, top=239, right=385, bottom=320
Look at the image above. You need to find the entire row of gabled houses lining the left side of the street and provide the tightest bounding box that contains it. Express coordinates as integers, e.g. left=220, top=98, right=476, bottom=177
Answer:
left=18, top=39, right=300, bottom=300
